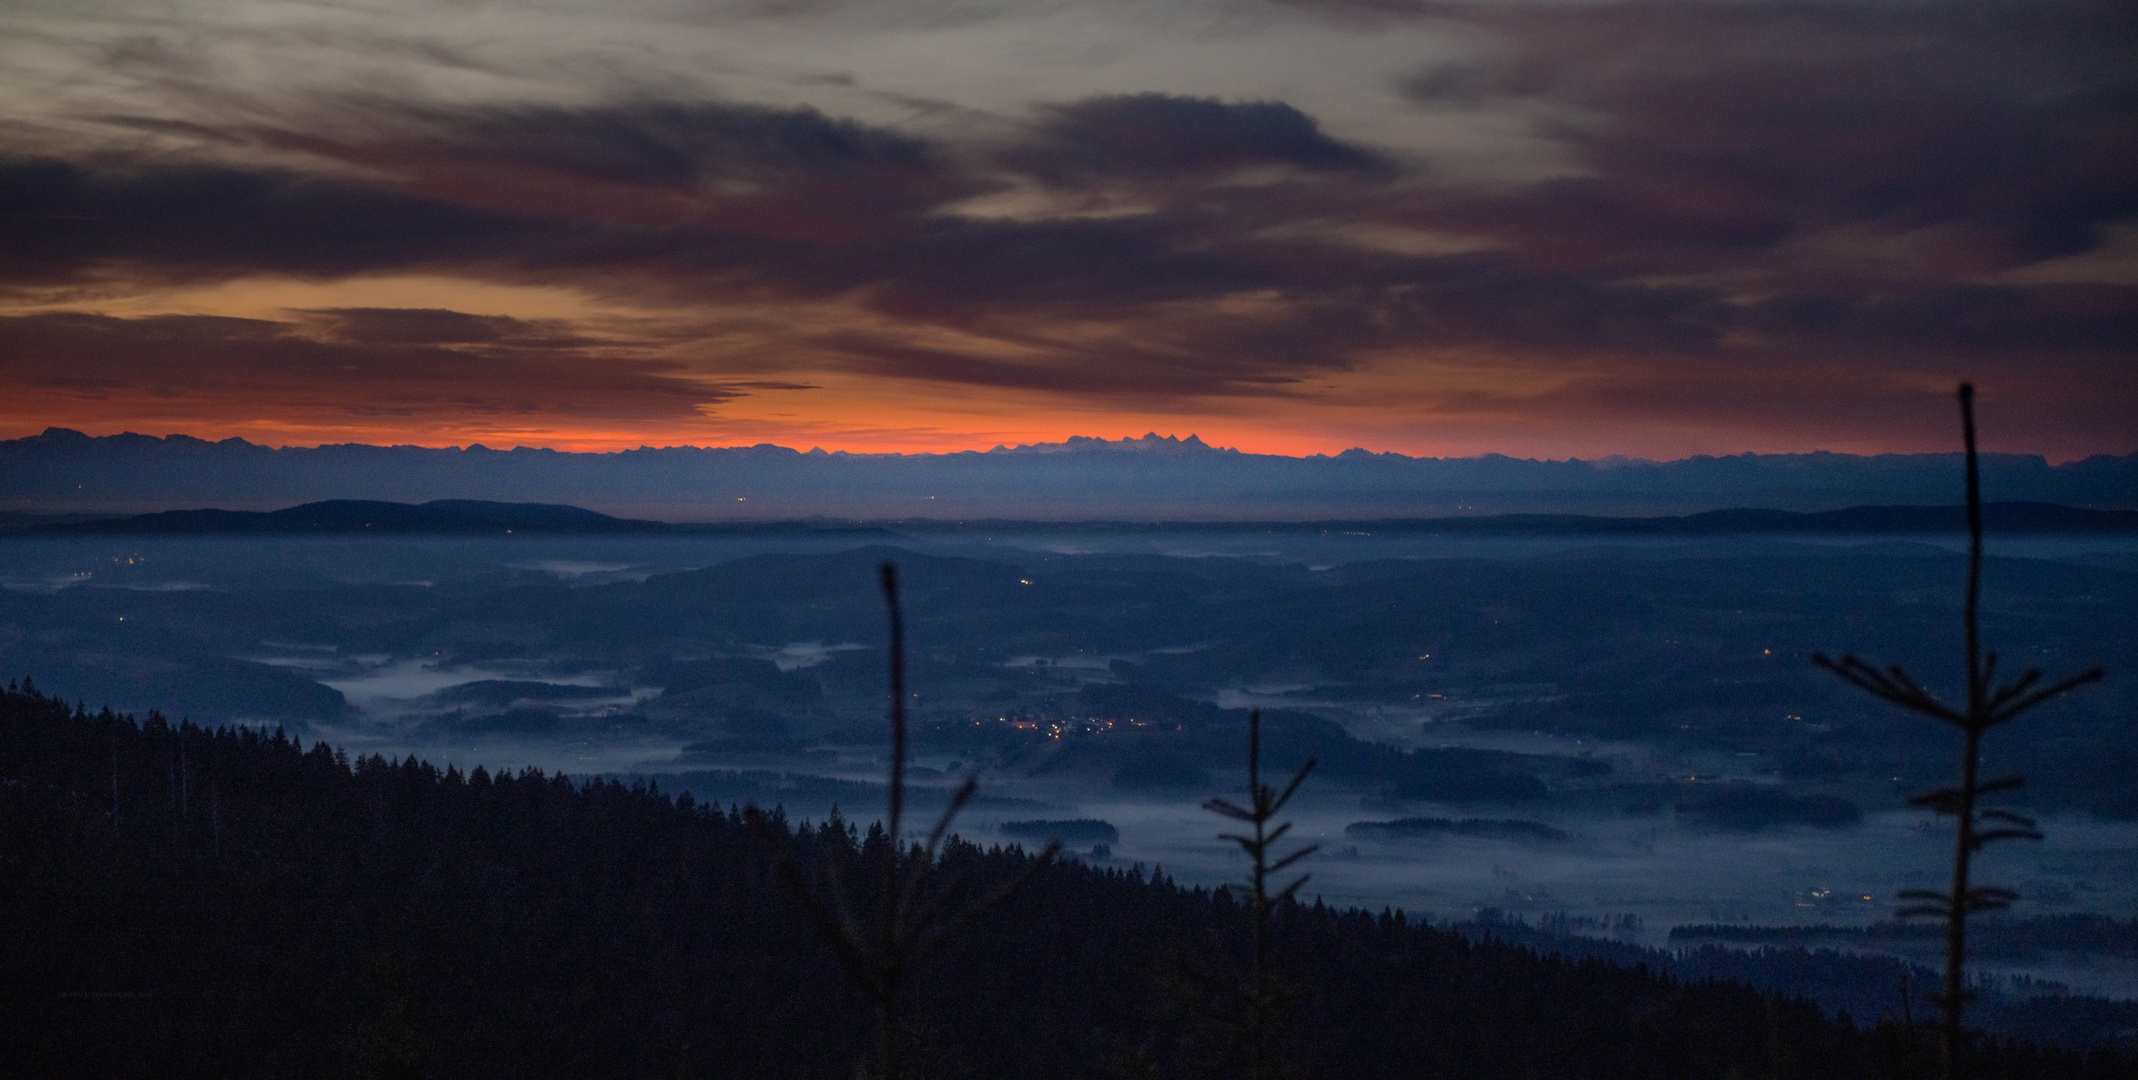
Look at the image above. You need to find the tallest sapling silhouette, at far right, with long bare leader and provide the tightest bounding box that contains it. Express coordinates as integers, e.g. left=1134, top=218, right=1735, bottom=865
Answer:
left=1811, top=383, right=2104, bottom=1080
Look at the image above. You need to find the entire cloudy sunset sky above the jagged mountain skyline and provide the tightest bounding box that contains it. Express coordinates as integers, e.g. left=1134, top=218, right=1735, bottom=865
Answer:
left=0, top=0, right=2138, bottom=462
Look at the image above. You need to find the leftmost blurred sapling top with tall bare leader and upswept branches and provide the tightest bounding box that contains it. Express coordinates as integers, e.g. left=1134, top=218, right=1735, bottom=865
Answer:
left=744, top=562, right=1060, bottom=1080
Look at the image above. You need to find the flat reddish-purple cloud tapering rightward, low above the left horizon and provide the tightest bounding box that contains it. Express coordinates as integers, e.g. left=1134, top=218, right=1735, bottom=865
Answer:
left=0, top=308, right=744, bottom=436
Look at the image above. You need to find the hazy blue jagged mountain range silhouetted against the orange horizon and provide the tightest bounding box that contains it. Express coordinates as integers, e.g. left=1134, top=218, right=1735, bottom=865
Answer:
left=0, top=428, right=2138, bottom=517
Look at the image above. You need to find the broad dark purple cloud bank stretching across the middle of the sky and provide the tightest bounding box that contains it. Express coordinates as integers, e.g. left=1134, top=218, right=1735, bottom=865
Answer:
left=0, top=0, right=2138, bottom=432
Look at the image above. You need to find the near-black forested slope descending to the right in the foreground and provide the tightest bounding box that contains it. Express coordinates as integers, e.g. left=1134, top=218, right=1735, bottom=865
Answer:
left=0, top=684, right=2132, bottom=1080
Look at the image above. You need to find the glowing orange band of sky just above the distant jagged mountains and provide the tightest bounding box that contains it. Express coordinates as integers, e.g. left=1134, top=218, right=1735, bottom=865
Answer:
left=0, top=276, right=2138, bottom=462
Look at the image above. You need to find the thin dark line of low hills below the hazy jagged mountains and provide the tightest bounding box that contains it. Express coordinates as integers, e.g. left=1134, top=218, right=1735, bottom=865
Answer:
left=16, top=498, right=2138, bottom=537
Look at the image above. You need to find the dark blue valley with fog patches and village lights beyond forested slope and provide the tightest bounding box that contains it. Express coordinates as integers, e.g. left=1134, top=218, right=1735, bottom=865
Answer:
left=0, top=524, right=2138, bottom=997
